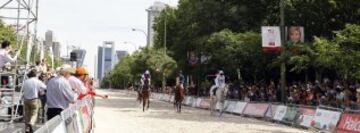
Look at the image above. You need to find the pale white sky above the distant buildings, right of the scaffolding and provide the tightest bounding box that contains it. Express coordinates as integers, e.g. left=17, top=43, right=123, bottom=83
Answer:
left=38, top=0, right=178, bottom=74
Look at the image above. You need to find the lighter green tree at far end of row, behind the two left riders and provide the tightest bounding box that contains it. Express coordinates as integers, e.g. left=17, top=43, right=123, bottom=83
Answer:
left=103, top=48, right=177, bottom=87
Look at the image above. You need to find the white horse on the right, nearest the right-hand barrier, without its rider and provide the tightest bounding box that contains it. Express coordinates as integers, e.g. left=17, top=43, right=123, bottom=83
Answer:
left=210, top=85, right=229, bottom=116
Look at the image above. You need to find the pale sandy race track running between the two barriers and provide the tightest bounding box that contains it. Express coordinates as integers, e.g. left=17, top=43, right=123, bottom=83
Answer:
left=95, top=90, right=307, bottom=133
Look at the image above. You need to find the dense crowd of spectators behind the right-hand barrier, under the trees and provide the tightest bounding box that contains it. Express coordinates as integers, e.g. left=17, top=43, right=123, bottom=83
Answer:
left=228, top=79, right=360, bottom=109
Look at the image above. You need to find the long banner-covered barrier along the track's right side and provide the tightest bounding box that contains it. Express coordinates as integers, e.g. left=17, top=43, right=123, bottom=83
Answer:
left=152, top=93, right=360, bottom=133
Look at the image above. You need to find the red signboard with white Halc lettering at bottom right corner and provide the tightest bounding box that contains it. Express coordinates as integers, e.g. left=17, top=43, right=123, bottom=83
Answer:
left=337, top=113, right=360, bottom=133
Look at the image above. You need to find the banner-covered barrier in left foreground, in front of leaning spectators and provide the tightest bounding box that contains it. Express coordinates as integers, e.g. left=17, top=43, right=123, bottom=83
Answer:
left=35, top=97, right=94, bottom=133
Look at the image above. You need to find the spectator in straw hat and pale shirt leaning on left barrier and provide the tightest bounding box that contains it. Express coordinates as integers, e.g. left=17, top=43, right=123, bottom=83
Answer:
left=46, top=65, right=78, bottom=120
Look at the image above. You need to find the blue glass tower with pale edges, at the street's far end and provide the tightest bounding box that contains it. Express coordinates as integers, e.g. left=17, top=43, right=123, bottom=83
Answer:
left=97, top=41, right=117, bottom=80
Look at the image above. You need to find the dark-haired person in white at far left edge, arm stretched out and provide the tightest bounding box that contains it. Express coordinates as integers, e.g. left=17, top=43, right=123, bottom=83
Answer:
left=0, top=41, right=20, bottom=68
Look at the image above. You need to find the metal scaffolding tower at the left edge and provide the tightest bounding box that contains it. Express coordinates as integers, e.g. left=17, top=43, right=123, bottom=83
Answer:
left=0, top=0, right=42, bottom=123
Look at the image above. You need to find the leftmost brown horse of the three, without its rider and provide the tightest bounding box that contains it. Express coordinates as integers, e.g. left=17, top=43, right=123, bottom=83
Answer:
left=139, top=78, right=150, bottom=112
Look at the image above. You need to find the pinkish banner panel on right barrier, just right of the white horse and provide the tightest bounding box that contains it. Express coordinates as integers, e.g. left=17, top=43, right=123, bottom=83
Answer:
left=243, top=103, right=269, bottom=117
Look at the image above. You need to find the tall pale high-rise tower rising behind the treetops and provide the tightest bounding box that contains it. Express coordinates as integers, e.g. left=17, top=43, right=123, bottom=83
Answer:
left=146, top=2, right=166, bottom=46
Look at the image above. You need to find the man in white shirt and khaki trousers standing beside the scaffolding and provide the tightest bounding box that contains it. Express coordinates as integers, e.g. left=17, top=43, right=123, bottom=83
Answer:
left=23, top=69, right=46, bottom=132
